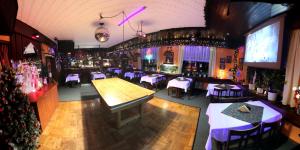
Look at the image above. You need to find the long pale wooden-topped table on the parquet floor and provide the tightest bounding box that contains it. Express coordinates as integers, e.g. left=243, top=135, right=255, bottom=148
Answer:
left=92, top=78, right=154, bottom=128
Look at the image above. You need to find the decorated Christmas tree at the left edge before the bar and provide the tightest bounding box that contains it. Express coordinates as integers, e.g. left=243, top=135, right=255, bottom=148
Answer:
left=0, top=67, right=40, bottom=149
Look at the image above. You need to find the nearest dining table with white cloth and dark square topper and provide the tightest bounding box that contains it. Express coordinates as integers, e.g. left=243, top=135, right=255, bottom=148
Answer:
left=205, top=100, right=282, bottom=150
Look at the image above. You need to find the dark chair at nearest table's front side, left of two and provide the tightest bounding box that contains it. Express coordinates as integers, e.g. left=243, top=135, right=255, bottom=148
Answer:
left=225, top=124, right=261, bottom=150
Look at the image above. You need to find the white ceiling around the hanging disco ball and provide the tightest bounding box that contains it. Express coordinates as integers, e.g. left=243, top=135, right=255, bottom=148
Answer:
left=17, top=0, right=206, bottom=48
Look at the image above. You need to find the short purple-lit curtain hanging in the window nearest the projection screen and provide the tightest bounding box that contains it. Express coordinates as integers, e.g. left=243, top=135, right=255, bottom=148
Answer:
left=183, top=46, right=210, bottom=62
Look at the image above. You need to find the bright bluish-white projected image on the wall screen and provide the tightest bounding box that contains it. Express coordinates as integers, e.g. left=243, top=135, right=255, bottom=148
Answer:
left=245, top=22, right=280, bottom=63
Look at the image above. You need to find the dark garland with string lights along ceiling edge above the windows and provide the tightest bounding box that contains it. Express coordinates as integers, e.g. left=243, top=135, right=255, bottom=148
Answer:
left=110, top=27, right=228, bottom=51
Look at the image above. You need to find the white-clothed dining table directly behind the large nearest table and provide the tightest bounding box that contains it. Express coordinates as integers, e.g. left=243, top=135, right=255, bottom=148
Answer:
left=206, top=83, right=242, bottom=97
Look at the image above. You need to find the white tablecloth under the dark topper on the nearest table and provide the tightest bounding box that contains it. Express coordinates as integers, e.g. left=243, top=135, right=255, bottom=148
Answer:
left=205, top=101, right=282, bottom=150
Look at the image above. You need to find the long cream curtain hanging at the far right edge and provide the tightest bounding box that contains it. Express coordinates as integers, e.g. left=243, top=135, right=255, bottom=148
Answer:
left=282, top=29, right=300, bottom=107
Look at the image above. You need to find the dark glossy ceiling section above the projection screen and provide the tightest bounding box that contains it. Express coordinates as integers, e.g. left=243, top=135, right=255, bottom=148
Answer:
left=206, top=0, right=288, bottom=47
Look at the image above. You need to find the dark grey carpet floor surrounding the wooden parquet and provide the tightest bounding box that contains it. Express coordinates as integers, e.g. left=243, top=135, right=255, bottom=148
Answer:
left=59, top=84, right=297, bottom=150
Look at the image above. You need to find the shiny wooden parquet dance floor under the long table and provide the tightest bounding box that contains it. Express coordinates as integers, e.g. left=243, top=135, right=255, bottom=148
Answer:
left=39, top=97, right=200, bottom=150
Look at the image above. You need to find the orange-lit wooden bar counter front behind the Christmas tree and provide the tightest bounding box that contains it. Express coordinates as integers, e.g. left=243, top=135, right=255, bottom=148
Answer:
left=28, top=83, right=58, bottom=130
